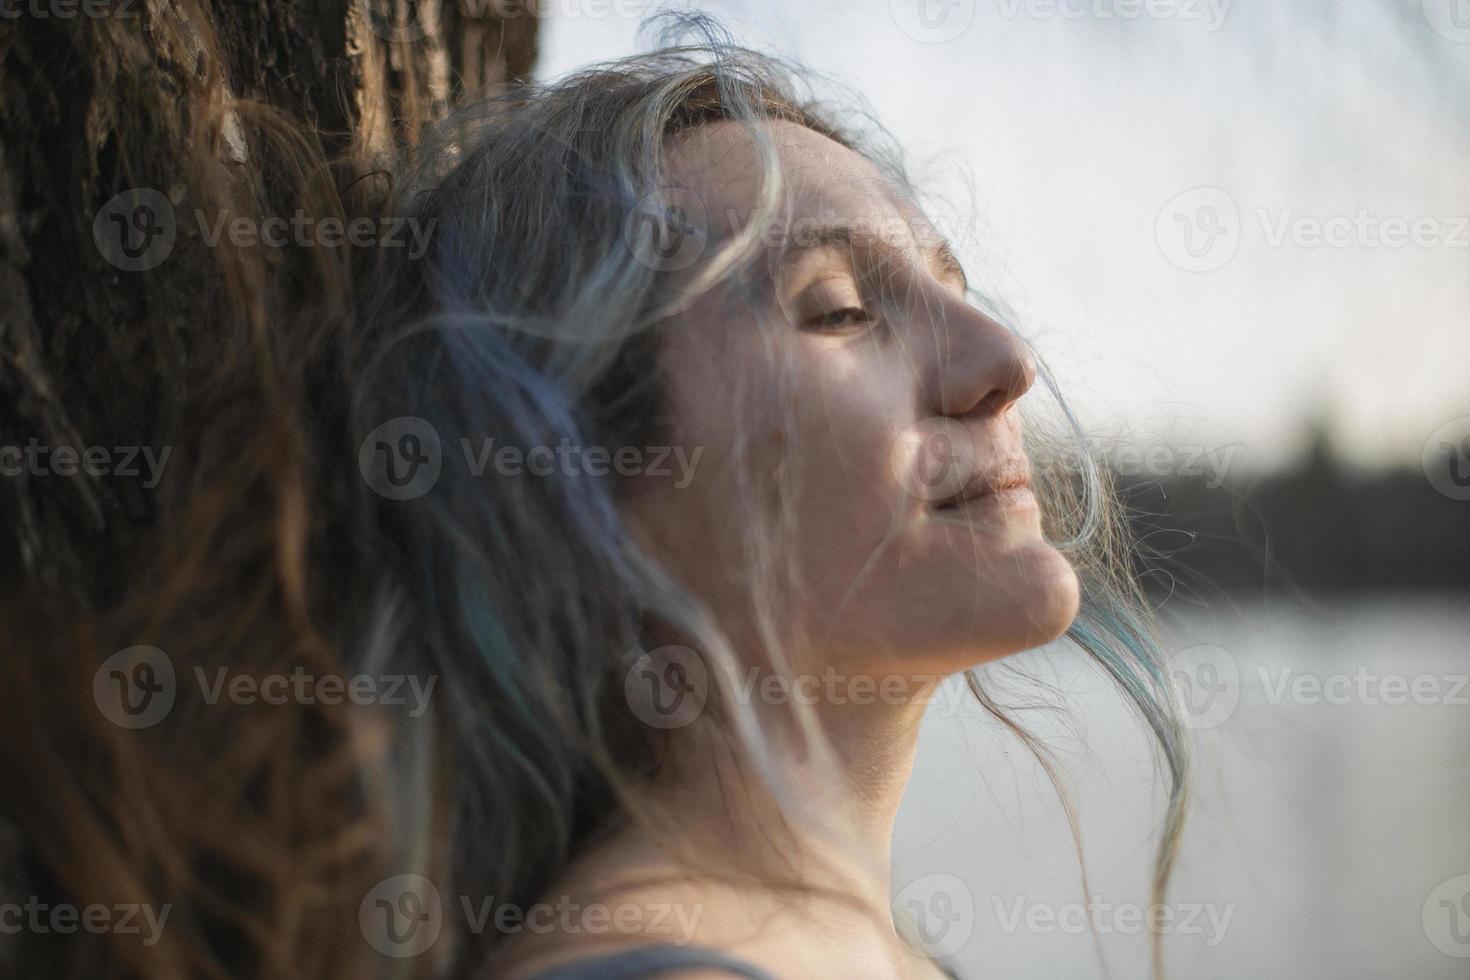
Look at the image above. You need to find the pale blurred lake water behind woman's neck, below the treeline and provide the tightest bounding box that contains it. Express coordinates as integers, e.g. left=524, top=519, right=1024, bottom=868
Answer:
left=894, top=595, right=1470, bottom=980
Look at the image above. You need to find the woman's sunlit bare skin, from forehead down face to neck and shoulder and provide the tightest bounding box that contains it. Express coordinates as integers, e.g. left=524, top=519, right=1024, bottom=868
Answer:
left=493, top=123, right=1078, bottom=977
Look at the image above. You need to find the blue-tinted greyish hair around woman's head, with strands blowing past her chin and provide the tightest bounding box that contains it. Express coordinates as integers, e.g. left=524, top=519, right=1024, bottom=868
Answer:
left=334, top=17, right=1186, bottom=973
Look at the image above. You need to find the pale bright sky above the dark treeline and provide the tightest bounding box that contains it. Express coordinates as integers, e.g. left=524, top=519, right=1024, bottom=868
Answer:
left=539, top=0, right=1470, bottom=464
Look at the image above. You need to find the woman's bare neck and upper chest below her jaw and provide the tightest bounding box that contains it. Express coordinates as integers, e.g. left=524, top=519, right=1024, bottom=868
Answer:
left=507, top=675, right=933, bottom=977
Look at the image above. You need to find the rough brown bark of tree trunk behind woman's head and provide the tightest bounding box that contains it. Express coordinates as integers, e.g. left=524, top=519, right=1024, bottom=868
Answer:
left=0, top=0, right=537, bottom=607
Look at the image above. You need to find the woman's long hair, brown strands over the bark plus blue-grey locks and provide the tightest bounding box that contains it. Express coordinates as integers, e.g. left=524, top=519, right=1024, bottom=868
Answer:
left=6, top=15, right=1186, bottom=977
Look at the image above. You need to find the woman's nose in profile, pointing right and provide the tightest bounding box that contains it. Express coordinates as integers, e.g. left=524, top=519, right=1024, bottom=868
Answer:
left=925, top=297, right=1036, bottom=417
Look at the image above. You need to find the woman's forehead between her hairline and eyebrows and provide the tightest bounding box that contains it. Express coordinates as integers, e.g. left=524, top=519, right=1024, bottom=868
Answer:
left=667, top=120, right=938, bottom=244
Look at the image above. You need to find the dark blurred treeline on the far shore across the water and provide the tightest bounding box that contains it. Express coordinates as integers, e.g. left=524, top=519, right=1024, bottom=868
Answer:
left=1114, top=439, right=1470, bottom=598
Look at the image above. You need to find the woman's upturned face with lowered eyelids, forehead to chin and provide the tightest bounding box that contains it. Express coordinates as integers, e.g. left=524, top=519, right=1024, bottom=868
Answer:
left=629, top=123, right=1078, bottom=690
